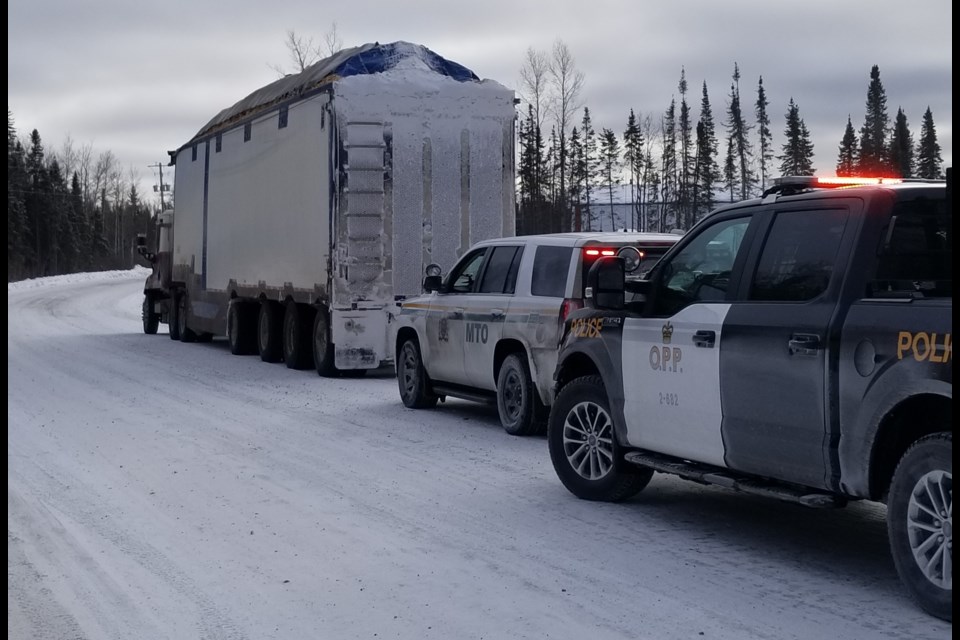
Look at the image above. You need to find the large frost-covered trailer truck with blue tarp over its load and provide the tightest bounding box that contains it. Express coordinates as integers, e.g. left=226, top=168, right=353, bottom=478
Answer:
left=144, top=42, right=515, bottom=375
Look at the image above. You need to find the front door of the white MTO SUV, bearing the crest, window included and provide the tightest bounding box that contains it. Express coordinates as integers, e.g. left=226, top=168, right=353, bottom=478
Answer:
left=423, top=247, right=487, bottom=384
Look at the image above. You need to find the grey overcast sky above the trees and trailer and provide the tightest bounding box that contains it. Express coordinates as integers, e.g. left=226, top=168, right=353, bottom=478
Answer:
left=7, top=0, right=953, bottom=205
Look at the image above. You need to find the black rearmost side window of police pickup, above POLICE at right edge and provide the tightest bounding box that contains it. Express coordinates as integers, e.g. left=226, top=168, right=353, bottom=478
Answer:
left=867, top=199, right=953, bottom=298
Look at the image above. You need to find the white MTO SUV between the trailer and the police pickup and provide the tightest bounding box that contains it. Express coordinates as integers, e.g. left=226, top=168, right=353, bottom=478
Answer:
left=394, top=232, right=680, bottom=435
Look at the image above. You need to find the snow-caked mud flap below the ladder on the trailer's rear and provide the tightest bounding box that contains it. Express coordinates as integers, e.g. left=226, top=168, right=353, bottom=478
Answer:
left=330, top=309, right=387, bottom=369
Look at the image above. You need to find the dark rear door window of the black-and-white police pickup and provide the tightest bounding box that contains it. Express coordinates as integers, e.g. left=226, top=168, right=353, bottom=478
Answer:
left=749, top=209, right=847, bottom=302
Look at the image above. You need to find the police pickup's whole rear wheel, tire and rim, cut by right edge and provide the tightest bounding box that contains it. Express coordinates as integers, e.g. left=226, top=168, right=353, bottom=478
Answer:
left=887, top=433, right=953, bottom=621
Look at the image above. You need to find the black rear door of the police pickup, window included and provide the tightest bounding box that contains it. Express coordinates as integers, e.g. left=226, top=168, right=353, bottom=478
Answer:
left=720, top=208, right=856, bottom=487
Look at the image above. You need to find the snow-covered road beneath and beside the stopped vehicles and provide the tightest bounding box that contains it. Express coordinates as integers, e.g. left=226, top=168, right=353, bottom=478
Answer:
left=7, top=270, right=951, bottom=640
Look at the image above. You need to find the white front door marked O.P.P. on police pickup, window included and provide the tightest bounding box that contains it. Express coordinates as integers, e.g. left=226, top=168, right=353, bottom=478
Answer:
left=623, top=215, right=752, bottom=466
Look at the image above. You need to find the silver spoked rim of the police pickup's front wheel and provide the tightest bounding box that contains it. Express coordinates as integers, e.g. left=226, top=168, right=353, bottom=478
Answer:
left=562, top=402, right=614, bottom=480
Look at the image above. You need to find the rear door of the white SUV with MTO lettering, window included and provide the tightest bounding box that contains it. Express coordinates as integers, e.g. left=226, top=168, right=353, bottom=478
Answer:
left=460, top=244, right=523, bottom=384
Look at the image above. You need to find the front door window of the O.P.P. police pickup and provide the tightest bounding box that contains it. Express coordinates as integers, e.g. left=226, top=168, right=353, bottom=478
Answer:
left=653, top=217, right=751, bottom=315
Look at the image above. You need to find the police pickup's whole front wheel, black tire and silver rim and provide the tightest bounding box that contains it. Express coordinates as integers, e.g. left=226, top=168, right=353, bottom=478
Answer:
left=547, top=376, right=653, bottom=502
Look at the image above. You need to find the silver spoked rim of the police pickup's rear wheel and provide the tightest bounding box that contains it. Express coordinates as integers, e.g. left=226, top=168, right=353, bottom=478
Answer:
left=907, top=469, right=953, bottom=590
